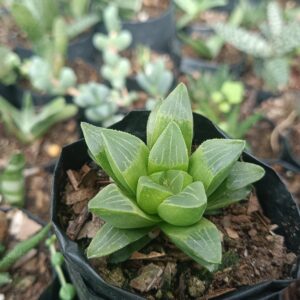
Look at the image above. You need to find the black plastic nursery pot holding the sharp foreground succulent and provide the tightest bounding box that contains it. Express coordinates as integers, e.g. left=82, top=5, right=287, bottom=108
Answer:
left=51, top=111, right=300, bottom=300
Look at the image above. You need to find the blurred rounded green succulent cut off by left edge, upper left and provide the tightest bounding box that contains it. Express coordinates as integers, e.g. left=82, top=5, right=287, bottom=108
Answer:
left=0, top=46, right=21, bottom=85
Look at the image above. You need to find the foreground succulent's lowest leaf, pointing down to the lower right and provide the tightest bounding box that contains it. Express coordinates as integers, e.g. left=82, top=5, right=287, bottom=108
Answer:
left=160, top=218, right=222, bottom=271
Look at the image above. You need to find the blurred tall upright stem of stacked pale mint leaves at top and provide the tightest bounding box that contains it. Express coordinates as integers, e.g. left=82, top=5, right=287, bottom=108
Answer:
left=94, top=4, right=136, bottom=106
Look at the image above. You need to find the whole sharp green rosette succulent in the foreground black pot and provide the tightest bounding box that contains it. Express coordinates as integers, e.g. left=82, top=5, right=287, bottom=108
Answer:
left=82, top=84, right=264, bottom=271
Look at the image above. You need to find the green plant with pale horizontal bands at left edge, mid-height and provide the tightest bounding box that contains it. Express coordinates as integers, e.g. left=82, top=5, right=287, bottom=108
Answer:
left=0, top=153, right=25, bottom=207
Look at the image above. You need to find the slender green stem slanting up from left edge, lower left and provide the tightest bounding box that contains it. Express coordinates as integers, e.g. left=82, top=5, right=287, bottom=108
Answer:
left=0, top=223, right=51, bottom=271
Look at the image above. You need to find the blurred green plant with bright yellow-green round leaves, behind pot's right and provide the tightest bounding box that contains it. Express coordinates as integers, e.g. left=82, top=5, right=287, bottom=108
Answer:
left=188, top=67, right=261, bottom=138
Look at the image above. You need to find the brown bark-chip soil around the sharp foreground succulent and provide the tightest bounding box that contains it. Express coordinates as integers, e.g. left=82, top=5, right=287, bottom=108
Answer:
left=59, top=165, right=296, bottom=299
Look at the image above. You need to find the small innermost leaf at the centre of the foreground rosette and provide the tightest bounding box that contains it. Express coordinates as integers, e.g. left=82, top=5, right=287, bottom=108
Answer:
left=150, top=170, right=193, bottom=195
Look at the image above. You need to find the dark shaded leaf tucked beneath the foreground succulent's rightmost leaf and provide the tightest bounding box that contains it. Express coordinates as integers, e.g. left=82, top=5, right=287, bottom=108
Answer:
left=205, top=183, right=252, bottom=212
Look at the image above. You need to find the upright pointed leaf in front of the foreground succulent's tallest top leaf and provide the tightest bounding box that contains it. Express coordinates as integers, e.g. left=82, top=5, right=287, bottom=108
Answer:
left=148, top=122, right=189, bottom=173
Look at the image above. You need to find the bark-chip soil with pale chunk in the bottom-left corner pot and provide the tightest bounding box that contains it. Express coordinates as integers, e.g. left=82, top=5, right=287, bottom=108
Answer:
left=0, top=209, right=52, bottom=300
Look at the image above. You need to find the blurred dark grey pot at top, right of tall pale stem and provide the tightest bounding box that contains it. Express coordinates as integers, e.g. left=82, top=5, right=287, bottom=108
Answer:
left=98, top=0, right=176, bottom=53
